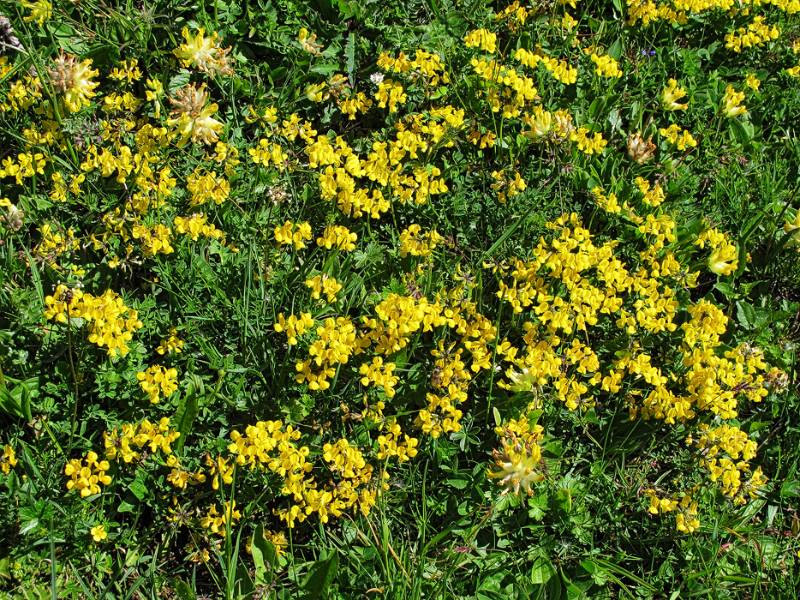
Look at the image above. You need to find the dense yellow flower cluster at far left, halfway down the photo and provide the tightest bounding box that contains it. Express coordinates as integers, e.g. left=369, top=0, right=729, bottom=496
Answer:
left=44, top=284, right=142, bottom=357
